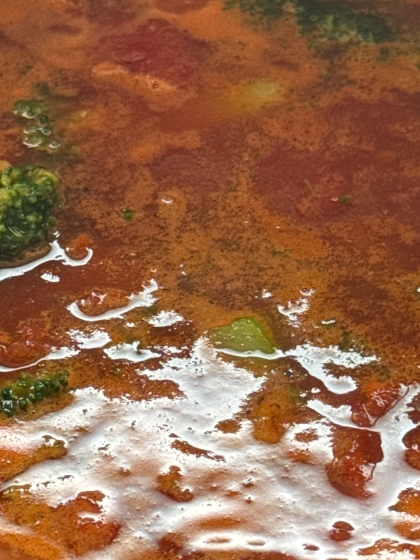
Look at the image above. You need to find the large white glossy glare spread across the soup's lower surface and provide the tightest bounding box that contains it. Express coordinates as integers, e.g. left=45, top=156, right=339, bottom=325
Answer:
left=2, top=339, right=420, bottom=560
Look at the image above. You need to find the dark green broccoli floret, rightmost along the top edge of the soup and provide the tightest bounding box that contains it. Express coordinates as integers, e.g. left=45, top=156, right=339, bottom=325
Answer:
left=296, top=0, right=392, bottom=43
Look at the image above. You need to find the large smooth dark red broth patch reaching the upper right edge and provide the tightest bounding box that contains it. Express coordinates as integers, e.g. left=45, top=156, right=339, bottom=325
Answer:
left=256, top=92, right=420, bottom=225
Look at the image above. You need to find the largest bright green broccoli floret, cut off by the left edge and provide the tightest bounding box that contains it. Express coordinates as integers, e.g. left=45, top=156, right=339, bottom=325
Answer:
left=0, top=166, right=59, bottom=260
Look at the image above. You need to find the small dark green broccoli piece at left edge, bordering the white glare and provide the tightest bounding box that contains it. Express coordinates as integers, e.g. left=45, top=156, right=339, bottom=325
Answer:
left=0, top=371, right=69, bottom=416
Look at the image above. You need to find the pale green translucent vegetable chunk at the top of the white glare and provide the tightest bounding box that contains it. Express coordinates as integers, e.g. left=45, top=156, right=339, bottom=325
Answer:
left=209, top=317, right=274, bottom=354
